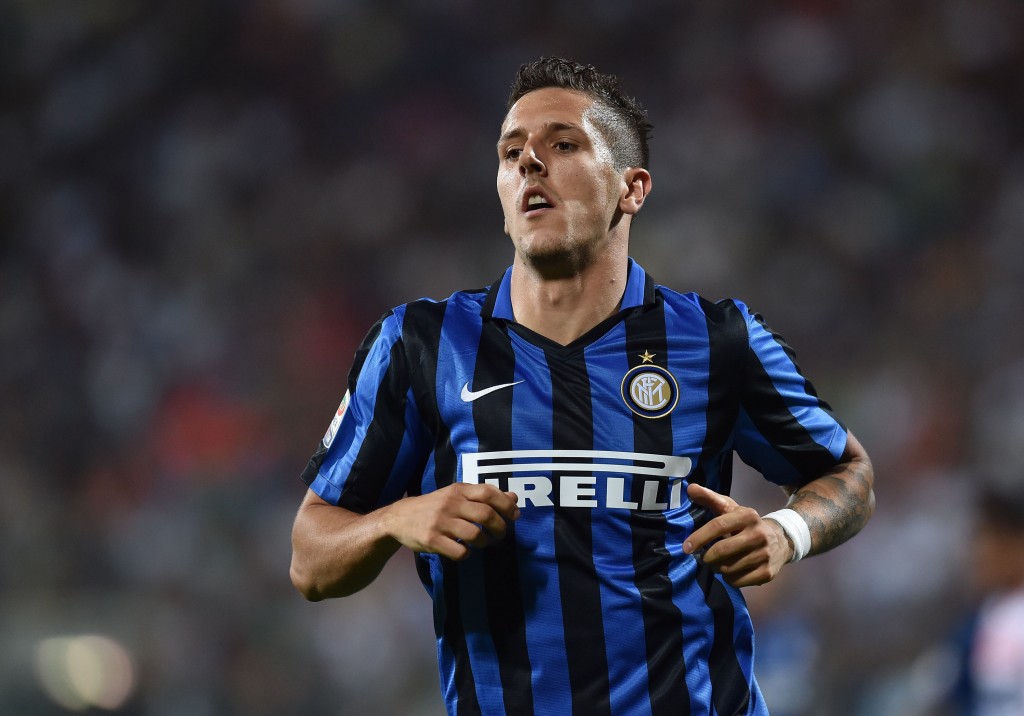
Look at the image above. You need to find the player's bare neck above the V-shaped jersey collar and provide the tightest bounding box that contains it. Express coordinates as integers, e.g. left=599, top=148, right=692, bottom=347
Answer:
left=510, top=242, right=629, bottom=345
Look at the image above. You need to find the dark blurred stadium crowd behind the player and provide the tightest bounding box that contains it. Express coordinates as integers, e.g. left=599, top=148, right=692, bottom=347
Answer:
left=0, top=0, right=1024, bottom=716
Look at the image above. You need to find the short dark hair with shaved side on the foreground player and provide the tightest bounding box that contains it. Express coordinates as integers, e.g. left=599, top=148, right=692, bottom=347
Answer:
left=505, top=57, right=652, bottom=169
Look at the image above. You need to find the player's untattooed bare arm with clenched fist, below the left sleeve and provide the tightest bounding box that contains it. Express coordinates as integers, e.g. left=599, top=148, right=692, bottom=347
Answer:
left=291, top=482, right=519, bottom=601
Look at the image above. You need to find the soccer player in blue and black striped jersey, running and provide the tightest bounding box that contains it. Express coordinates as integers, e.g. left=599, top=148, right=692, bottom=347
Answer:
left=291, top=58, right=873, bottom=716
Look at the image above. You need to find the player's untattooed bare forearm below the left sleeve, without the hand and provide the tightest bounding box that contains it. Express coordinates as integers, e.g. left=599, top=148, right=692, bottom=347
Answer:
left=291, top=494, right=400, bottom=601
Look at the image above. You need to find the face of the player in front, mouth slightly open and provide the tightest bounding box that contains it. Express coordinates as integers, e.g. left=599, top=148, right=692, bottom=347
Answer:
left=498, top=88, right=627, bottom=263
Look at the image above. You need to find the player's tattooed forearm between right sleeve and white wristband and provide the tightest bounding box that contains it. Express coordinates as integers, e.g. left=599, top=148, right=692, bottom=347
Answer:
left=787, top=433, right=874, bottom=554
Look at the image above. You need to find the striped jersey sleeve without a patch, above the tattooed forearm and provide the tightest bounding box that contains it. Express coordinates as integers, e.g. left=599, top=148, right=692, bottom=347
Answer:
left=735, top=301, right=847, bottom=486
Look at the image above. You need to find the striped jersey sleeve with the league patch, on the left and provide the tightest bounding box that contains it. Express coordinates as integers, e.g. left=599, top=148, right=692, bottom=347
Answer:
left=302, top=311, right=426, bottom=513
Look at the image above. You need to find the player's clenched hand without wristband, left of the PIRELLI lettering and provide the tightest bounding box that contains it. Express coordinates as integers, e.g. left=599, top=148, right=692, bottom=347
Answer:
left=384, top=482, right=519, bottom=559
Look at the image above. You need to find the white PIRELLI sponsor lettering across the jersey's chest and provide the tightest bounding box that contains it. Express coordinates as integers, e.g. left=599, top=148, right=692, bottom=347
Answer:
left=462, top=450, right=692, bottom=511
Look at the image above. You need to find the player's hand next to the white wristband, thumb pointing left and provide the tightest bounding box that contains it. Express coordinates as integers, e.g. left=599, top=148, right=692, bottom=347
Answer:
left=683, top=483, right=793, bottom=587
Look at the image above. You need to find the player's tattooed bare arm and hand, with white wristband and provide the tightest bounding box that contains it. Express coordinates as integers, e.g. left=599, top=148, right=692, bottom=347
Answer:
left=683, top=433, right=874, bottom=587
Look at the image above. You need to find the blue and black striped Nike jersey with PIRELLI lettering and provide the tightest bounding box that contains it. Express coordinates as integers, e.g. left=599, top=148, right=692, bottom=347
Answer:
left=303, top=260, right=846, bottom=716
